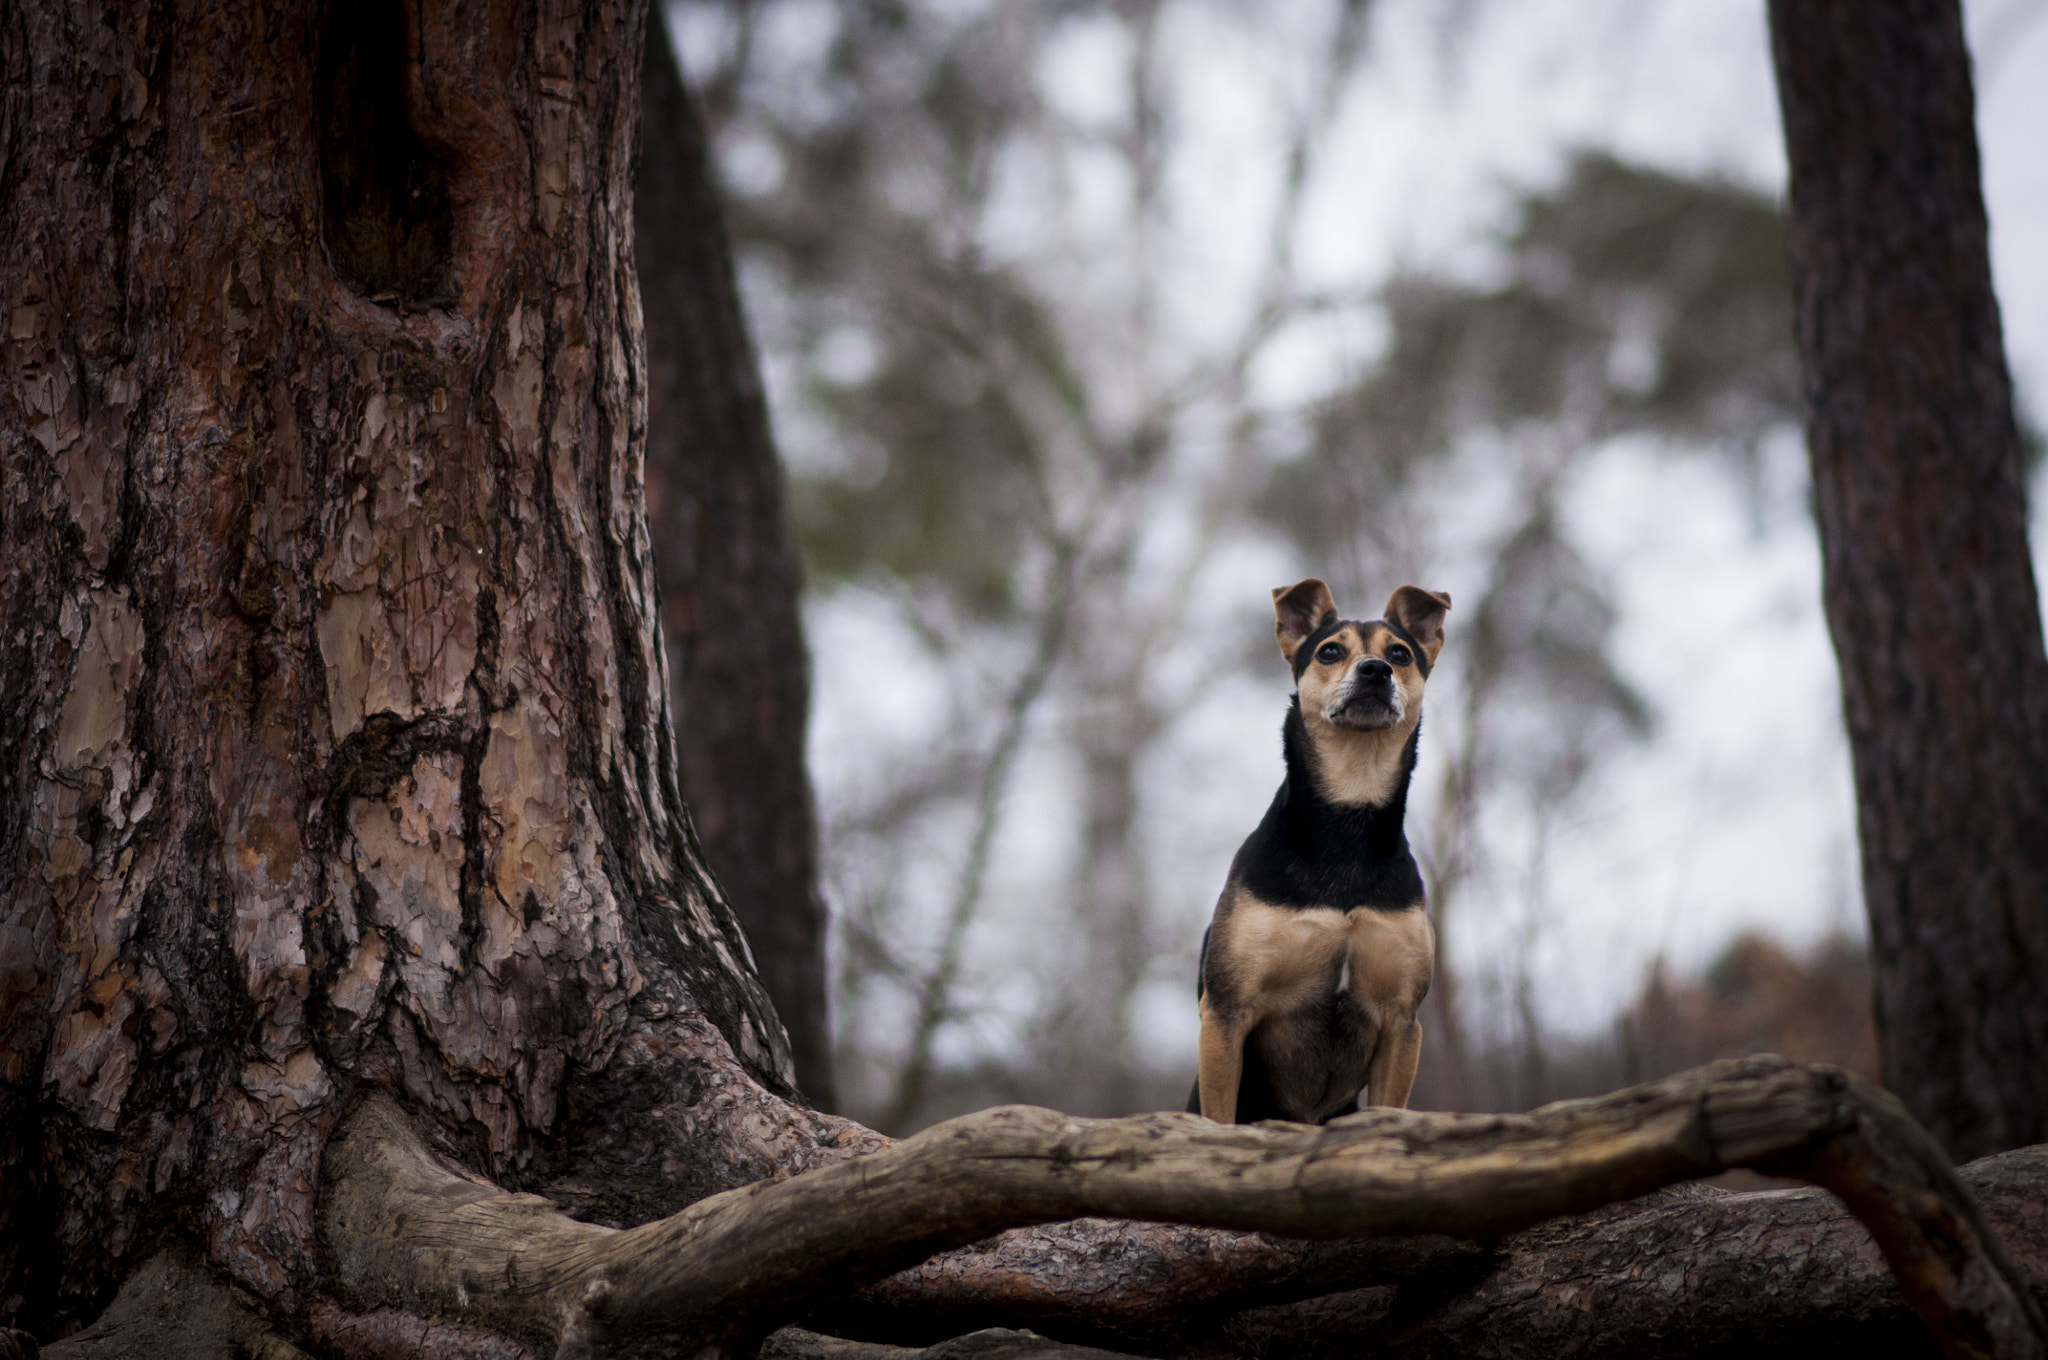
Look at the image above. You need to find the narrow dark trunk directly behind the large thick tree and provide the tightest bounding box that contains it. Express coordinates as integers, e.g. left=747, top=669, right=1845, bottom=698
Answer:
left=633, top=6, right=834, bottom=1108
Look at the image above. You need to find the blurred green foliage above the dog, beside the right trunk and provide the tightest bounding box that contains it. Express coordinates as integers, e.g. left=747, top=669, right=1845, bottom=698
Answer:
left=1260, top=154, right=1800, bottom=559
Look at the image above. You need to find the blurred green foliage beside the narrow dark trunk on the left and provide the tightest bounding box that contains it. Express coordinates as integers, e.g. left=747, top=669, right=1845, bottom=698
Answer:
left=696, top=0, right=1081, bottom=617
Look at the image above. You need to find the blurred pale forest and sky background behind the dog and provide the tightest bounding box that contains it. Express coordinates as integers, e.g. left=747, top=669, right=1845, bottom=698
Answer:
left=647, top=0, right=2044, bottom=1133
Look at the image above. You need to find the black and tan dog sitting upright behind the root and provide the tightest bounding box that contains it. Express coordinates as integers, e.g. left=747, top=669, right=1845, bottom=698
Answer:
left=1188, top=580, right=1450, bottom=1124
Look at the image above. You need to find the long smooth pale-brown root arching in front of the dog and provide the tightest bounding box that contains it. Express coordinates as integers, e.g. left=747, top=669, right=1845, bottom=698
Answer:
left=322, top=1059, right=2048, bottom=1360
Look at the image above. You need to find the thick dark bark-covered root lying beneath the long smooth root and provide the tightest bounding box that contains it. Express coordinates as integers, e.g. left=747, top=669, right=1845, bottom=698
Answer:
left=813, top=1147, right=2048, bottom=1360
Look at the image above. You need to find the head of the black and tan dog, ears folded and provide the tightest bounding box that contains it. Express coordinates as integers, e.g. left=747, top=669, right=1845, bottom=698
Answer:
left=1274, top=578, right=1450, bottom=731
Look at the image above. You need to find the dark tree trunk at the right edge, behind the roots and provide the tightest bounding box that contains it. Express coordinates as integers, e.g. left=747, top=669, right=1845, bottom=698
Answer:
left=1769, top=0, right=2048, bottom=1157
